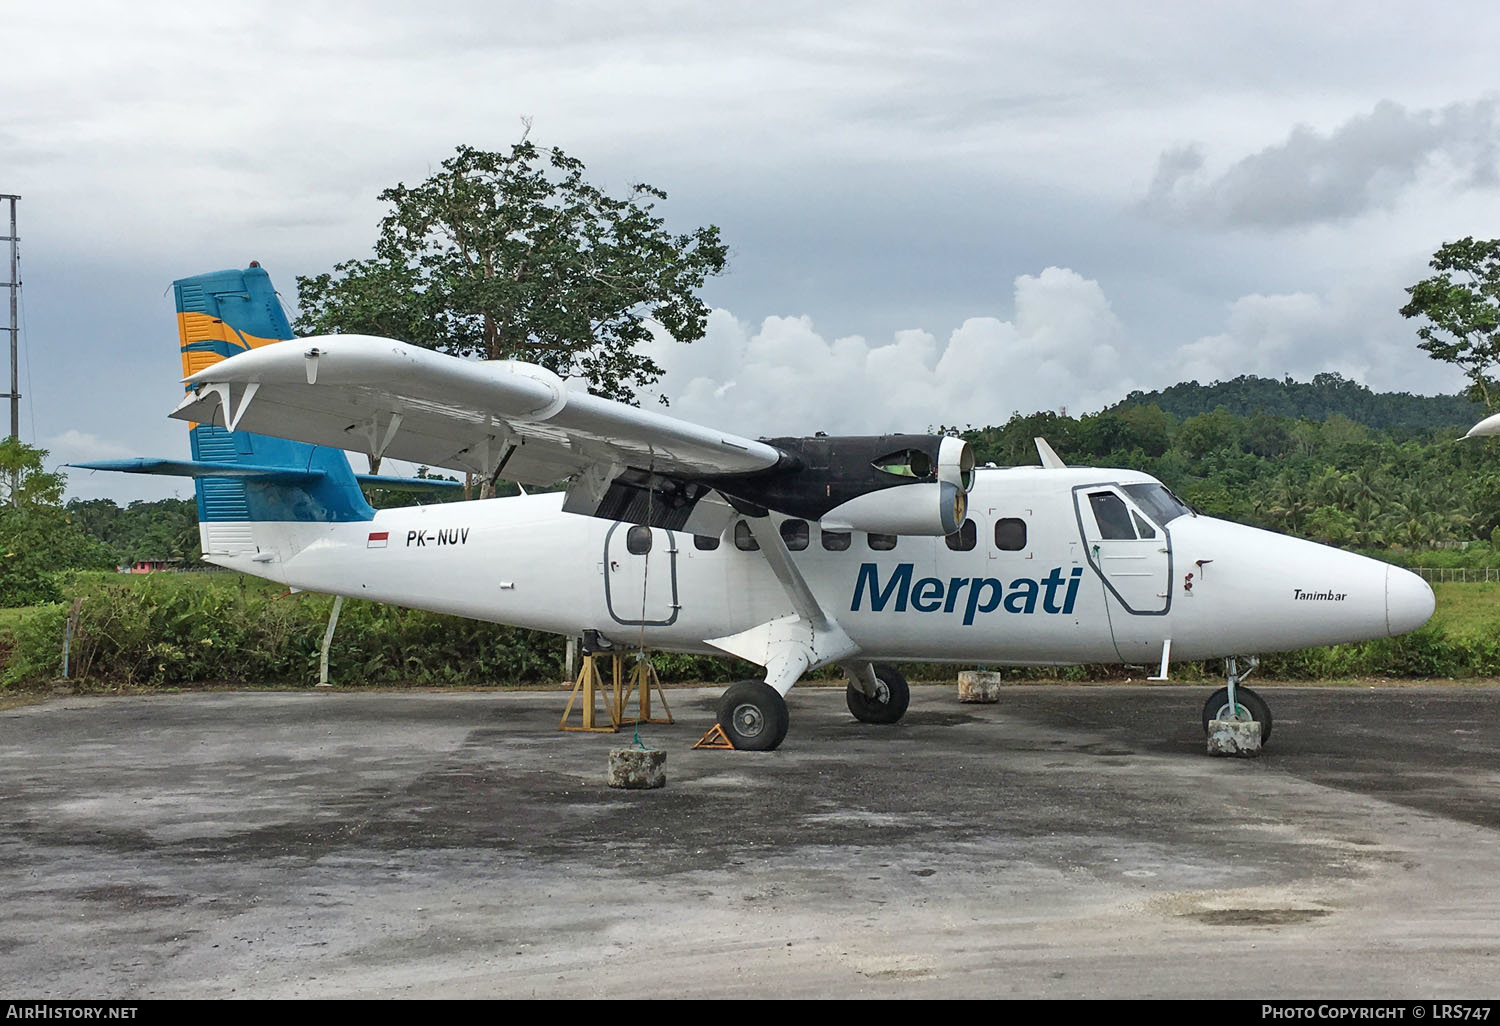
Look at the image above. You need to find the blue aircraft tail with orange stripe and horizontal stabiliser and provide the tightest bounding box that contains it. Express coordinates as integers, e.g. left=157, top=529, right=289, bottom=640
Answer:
left=75, top=264, right=375, bottom=558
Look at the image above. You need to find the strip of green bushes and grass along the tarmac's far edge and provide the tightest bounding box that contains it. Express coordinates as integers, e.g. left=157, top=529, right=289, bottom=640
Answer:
left=0, top=572, right=1500, bottom=687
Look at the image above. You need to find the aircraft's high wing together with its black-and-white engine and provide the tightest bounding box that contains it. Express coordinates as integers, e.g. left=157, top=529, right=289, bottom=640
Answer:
left=173, top=335, right=974, bottom=534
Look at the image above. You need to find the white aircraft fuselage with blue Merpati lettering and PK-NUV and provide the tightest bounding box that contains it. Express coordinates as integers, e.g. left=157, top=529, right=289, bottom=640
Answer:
left=203, top=467, right=1433, bottom=665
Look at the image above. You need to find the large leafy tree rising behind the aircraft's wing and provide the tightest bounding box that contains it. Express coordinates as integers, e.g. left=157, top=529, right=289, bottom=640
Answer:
left=296, top=138, right=728, bottom=402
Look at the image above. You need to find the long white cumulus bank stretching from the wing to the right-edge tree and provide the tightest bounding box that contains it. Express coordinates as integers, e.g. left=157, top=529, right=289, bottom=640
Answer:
left=651, top=267, right=1458, bottom=437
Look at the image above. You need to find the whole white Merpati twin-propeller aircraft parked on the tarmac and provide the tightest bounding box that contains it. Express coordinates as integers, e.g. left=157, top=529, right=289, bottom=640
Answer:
left=81, top=264, right=1433, bottom=750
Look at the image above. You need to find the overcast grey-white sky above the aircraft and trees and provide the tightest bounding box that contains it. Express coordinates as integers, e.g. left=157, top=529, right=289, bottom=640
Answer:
left=0, top=0, right=1500, bottom=503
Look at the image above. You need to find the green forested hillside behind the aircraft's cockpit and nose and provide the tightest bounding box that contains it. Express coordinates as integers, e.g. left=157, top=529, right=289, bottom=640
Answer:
left=963, top=374, right=1500, bottom=566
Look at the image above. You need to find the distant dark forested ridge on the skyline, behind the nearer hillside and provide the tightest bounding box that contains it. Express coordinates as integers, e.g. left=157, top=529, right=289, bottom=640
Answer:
left=1110, top=374, right=1485, bottom=432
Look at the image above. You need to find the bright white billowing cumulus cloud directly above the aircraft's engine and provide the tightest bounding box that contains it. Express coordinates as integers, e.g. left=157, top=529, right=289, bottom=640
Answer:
left=651, top=267, right=1133, bottom=435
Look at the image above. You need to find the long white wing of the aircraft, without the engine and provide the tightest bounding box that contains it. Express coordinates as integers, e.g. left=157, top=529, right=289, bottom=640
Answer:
left=171, top=335, right=782, bottom=485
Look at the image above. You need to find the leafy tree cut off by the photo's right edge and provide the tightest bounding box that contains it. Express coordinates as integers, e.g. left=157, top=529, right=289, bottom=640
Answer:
left=1401, top=237, right=1500, bottom=411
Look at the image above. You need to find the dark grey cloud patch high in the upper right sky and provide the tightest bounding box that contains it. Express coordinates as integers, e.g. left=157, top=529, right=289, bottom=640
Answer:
left=1142, top=99, right=1500, bottom=228
